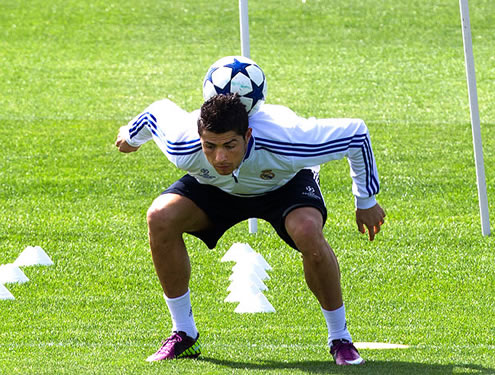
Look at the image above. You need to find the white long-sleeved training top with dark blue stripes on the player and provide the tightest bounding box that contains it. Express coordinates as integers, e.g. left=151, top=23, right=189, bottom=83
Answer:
left=126, top=99, right=379, bottom=208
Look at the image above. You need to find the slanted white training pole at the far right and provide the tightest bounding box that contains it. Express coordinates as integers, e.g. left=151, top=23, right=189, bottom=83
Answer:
left=459, top=0, right=490, bottom=236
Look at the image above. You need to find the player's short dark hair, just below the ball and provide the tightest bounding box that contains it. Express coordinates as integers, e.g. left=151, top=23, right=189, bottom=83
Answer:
left=198, top=94, right=249, bottom=136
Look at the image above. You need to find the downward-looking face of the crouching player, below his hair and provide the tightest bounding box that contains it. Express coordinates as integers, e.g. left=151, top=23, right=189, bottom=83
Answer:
left=201, top=128, right=251, bottom=176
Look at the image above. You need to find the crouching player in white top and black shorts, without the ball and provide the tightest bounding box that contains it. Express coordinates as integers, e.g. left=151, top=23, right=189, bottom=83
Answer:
left=116, top=94, right=385, bottom=365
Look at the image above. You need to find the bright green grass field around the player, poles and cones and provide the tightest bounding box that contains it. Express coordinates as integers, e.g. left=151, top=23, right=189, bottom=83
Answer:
left=0, top=0, right=495, bottom=375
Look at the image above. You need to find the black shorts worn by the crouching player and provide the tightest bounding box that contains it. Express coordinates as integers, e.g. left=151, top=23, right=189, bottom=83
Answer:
left=162, top=169, right=327, bottom=250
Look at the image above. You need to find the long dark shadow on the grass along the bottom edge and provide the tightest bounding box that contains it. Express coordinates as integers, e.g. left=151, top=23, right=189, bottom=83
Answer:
left=198, top=357, right=495, bottom=375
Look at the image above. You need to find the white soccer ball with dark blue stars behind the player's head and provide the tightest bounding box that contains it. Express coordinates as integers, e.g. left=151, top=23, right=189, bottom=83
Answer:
left=203, top=56, right=266, bottom=116
